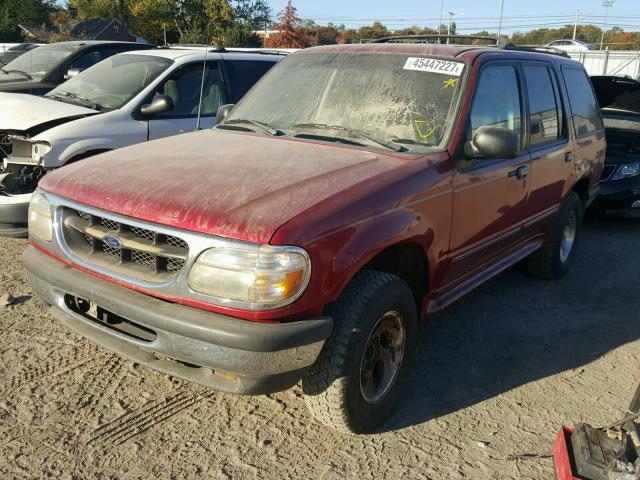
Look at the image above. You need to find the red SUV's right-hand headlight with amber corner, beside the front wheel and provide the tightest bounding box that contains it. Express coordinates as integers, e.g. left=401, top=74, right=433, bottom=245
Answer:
left=188, top=245, right=311, bottom=310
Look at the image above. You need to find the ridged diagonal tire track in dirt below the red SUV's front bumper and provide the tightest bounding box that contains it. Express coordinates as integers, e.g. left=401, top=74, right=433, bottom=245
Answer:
left=87, top=389, right=215, bottom=447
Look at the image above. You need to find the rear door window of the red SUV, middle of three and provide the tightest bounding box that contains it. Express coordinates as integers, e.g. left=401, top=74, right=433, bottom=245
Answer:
left=524, top=65, right=563, bottom=146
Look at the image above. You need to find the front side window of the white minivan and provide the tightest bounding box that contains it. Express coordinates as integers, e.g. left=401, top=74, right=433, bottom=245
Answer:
left=154, top=62, right=224, bottom=118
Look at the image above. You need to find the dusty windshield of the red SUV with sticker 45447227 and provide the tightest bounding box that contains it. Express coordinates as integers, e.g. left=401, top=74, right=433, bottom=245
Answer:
left=224, top=52, right=465, bottom=151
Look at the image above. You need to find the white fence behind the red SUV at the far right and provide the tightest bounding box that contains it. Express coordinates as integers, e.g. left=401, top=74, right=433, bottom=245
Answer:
left=569, top=50, right=640, bottom=80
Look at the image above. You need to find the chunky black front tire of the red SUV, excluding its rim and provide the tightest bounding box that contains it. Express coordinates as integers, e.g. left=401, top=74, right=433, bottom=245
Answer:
left=302, top=270, right=417, bottom=433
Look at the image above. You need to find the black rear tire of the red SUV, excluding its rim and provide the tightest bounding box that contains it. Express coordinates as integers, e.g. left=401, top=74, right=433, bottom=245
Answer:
left=528, top=191, right=584, bottom=279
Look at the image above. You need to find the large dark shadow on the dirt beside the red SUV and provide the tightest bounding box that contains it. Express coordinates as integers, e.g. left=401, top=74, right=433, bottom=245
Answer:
left=382, top=220, right=640, bottom=431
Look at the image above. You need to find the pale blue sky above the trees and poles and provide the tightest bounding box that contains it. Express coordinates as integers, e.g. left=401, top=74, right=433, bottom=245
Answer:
left=270, top=0, right=640, bottom=33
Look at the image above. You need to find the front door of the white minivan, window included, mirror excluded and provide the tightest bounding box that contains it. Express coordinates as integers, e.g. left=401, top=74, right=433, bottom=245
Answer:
left=147, top=61, right=226, bottom=140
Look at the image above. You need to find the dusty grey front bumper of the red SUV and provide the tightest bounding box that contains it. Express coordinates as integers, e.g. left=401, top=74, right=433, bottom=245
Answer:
left=23, top=247, right=333, bottom=395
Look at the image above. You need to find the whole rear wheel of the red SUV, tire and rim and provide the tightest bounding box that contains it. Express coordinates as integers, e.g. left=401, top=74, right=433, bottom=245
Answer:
left=529, top=192, right=583, bottom=279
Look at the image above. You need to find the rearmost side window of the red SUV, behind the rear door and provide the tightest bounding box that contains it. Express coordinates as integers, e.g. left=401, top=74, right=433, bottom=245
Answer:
left=562, top=67, right=603, bottom=137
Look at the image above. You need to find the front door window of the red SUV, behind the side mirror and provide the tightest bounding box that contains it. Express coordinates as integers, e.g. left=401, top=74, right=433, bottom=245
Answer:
left=470, top=65, right=522, bottom=144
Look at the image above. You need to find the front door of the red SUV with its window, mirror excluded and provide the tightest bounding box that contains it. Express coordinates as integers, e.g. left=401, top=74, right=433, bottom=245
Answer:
left=447, top=63, right=529, bottom=283
